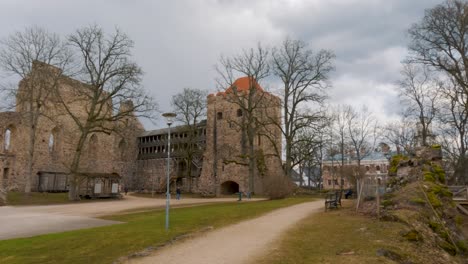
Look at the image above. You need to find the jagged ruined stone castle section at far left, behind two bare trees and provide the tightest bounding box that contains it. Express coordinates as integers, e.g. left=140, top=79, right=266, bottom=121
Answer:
left=0, top=61, right=143, bottom=195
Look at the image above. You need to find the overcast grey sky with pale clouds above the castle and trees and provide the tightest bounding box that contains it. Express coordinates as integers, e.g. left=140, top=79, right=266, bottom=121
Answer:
left=0, top=0, right=442, bottom=129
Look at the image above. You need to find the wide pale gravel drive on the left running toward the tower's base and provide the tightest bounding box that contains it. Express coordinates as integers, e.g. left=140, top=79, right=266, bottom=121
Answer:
left=0, top=195, right=260, bottom=240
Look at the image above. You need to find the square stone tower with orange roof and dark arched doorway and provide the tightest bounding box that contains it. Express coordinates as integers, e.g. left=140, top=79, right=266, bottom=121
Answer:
left=199, top=77, right=282, bottom=195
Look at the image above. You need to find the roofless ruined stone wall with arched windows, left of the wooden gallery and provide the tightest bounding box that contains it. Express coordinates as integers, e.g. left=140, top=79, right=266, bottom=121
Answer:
left=0, top=64, right=144, bottom=191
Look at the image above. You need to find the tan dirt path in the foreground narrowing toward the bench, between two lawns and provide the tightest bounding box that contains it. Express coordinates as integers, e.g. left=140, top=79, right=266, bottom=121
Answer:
left=127, top=201, right=323, bottom=264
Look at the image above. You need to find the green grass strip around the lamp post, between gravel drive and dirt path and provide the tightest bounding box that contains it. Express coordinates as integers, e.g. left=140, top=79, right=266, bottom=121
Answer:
left=0, top=198, right=311, bottom=264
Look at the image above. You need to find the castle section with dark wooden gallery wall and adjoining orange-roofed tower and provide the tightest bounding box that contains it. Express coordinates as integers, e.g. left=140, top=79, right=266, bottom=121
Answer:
left=137, top=77, right=283, bottom=195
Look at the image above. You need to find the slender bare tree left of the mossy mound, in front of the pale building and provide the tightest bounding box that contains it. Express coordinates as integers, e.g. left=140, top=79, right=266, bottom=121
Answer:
left=347, top=106, right=377, bottom=209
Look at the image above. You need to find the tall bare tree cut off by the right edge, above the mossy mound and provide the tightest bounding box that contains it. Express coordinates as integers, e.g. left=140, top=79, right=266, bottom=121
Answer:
left=409, top=0, right=468, bottom=184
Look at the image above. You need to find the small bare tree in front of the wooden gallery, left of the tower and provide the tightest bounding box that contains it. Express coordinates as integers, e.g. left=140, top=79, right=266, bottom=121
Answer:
left=171, top=88, right=208, bottom=191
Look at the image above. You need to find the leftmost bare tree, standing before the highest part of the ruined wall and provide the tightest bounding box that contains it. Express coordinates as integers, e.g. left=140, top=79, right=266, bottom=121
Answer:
left=0, top=27, right=70, bottom=194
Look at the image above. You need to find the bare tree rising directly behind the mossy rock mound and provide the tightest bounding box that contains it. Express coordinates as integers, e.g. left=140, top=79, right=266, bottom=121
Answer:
left=399, top=63, right=441, bottom=146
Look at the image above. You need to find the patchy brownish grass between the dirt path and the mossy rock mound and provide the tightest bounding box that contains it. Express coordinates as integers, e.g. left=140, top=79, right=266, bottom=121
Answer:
left=253, top=200, right=458, bottom=264
